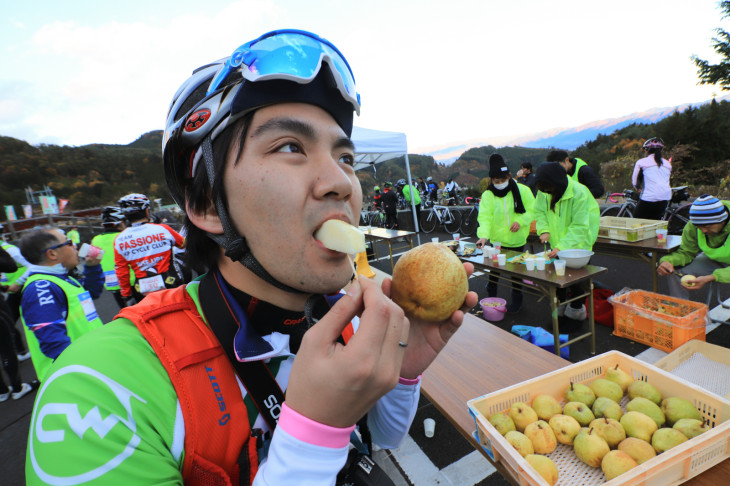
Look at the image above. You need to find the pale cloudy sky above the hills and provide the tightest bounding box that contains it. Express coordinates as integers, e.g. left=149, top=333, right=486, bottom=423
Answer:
left=0, top=0, right=730, bottom=153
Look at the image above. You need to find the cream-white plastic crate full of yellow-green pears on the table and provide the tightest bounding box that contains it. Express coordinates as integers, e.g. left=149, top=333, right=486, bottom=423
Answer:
left=467, top=351, right=730, bottom=486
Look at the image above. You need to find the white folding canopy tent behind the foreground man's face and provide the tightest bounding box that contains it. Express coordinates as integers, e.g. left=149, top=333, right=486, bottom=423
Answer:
left=351, top=127, right=418, bottom=232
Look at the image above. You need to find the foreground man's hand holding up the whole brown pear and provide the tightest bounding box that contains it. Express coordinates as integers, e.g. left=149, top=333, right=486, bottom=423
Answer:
left=383, top=263, right=479, bottom=379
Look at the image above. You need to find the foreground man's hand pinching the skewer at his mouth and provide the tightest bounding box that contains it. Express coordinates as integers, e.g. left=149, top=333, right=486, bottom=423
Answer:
left=286, top=277, right=410, bottom=427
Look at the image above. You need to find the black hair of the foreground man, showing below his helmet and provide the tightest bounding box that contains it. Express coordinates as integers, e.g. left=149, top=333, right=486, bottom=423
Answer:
left=182, top=112, right=254, bottom=274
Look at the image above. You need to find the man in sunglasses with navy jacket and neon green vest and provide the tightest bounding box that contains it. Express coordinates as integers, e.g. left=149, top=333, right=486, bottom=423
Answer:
left=20, top=227, right=104, bottom=381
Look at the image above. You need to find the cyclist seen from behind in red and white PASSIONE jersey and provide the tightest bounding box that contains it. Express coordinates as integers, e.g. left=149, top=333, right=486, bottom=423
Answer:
left=114, top=194, right=185, bottom=301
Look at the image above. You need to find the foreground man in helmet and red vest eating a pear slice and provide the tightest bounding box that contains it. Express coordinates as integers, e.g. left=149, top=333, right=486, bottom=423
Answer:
left=26, top=30, right=477, bottom=486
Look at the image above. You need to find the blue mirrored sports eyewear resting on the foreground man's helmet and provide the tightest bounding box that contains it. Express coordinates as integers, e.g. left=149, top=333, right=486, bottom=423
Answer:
left=207, top=29, right=360, bottom=115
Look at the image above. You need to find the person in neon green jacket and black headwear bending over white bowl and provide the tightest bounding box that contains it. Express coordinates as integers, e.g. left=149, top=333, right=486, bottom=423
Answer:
left=535, top=164, right=601, bottom=321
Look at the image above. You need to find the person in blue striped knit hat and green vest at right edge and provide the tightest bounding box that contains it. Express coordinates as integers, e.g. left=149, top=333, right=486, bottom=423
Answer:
left=657, top=194, right=730, bottom=299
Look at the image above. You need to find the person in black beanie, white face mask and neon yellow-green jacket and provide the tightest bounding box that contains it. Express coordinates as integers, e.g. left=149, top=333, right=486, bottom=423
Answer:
left=477, top=154, right=535, bottom=313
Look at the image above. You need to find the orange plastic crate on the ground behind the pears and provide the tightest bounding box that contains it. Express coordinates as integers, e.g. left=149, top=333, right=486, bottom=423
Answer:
left=608, top=290, right=708, bottom=353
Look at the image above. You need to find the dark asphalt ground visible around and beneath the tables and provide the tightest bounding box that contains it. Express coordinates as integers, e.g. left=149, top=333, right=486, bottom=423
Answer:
left=0, top=229, right=730, bottom=486
